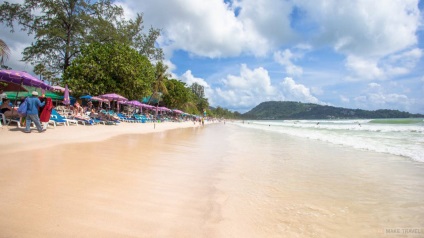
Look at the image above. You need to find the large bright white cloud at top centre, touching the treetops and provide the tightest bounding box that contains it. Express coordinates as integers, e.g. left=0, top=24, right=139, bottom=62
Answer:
left=120, top=0, right=293, bottom=58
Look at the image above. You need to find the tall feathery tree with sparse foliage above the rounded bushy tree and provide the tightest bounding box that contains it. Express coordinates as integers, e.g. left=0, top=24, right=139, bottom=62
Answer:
left=0, top=0, right=163, bottom=75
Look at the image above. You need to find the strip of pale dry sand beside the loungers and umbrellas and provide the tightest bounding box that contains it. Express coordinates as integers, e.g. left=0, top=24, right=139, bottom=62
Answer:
left=0, top=121, right=202, bottom=155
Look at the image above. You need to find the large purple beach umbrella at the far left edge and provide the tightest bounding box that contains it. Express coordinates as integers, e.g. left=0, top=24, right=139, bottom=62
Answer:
left=0, top=69, right=53, bottom=91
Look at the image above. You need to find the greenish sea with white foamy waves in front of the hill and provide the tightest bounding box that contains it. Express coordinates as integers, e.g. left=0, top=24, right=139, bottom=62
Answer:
left=240, top=118, right=424, bottom=162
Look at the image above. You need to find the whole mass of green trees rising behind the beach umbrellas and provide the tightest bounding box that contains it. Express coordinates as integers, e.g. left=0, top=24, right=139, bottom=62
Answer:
left=0, top=0, right=240, bottom=118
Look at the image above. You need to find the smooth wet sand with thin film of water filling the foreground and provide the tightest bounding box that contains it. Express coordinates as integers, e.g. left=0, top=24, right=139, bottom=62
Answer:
left=0, top=123, right=424, bottom=237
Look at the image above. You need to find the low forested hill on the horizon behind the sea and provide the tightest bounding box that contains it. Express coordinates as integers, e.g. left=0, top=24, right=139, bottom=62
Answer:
left=242, top=101, right=424, bottom=120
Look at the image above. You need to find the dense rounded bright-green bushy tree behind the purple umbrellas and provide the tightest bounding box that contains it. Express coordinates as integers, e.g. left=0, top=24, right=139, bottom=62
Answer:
left=63, top=43, right=155, bottom=100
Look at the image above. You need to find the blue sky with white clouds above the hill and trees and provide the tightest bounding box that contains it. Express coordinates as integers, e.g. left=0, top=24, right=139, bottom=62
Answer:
left=0, top=0, right=424, bottom=113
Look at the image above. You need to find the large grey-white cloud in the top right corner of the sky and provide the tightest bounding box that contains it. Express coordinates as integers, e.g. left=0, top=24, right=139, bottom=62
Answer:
left=296, top=0, right=420, bottom=57
